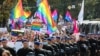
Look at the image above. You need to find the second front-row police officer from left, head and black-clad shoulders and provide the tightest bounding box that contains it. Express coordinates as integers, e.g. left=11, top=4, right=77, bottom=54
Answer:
left=17, top=39, right=32, bottom=56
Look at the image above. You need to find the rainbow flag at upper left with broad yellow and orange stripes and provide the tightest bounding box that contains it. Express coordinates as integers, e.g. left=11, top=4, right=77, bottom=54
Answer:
left=10, top=0, right=31, bottom=20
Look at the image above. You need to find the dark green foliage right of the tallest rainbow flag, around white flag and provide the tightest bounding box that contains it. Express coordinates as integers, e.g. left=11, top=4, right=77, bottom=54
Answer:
left=49, top=0, right=100, bottom=20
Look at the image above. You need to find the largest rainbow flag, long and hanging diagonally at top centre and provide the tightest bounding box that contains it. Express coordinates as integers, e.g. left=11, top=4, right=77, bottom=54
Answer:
left=37, top=0, right=57, bottom=33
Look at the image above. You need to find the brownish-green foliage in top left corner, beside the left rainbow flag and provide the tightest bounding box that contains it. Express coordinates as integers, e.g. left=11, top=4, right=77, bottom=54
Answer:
left=0, top=0, right=14, bottom=22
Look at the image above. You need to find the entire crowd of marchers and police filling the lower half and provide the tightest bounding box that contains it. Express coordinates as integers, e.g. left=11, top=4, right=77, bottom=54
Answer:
left=0, top=31, right=100, bottom=56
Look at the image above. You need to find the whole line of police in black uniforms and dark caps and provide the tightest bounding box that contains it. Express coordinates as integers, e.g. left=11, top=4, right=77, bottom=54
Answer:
left=0, top=33, right=100, bottom=56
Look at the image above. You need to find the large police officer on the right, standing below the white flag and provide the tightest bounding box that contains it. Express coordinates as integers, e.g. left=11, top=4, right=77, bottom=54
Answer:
left=77, top=34, right=89, bottom=56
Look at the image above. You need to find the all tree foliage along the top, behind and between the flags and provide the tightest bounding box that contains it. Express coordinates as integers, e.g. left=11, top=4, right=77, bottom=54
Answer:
left=0, top=0, right=100, bottom=21
